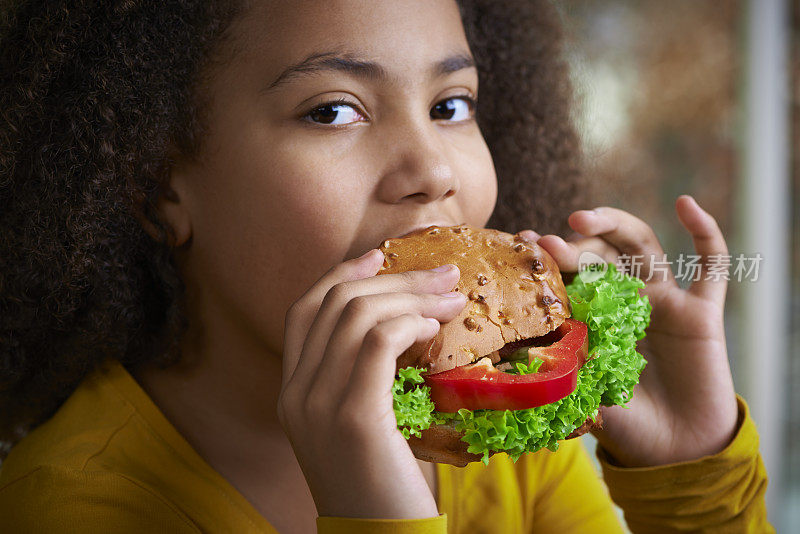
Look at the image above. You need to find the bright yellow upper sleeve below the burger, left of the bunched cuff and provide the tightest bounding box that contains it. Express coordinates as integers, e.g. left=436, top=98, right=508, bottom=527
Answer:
left=517, top=439, right=624, bottom=534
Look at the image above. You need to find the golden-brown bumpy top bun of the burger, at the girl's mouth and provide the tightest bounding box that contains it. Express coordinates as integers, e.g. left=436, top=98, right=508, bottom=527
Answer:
left=378, top=225, right=571, bottom=373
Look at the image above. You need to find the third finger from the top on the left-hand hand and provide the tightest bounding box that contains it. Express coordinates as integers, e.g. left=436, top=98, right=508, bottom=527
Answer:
left=311, top=291, right=467, bottom=396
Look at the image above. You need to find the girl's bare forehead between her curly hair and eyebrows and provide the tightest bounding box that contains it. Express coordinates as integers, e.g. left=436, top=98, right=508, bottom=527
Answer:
left=225, top=0, right=469, bottom=79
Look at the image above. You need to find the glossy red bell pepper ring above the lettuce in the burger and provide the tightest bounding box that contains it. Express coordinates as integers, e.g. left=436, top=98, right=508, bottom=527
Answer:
left=424, top=319, right=588, bottom=412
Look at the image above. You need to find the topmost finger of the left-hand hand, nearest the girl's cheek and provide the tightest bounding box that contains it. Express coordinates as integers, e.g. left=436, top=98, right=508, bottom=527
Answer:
left=281, top=249, right=385, bottom=386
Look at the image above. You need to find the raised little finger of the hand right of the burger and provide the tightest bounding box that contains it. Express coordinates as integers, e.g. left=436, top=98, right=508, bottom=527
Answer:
left=675, top=195, right=730, bottom=306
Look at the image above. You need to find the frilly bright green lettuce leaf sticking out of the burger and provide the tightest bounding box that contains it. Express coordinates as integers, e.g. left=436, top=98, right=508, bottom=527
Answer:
left=393, top=264, right=652, bottom=463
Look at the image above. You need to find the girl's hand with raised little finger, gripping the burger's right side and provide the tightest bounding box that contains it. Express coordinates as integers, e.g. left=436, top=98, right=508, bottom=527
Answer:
left=523, top=195, right=737, bottom=466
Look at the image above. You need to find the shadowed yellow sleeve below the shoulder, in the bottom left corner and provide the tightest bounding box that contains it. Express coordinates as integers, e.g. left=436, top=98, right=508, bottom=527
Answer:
left=0, top=465, right=200, bottom=534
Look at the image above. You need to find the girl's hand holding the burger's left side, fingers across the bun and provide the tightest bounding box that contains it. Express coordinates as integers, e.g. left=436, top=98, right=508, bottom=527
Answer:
left=278, top=250, right=466, bottom=518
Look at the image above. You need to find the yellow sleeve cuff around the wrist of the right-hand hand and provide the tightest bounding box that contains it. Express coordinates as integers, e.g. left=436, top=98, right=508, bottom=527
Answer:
left=597, top=396, right=775, bottom=533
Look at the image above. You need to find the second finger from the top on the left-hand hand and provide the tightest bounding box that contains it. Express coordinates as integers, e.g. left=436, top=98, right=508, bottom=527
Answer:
left=292, top=265, right=459, bottom=390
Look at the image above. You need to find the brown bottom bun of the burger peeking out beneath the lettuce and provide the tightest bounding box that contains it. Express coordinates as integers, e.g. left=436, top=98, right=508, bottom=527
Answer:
left=408, top=412, right=603, bottom=467
